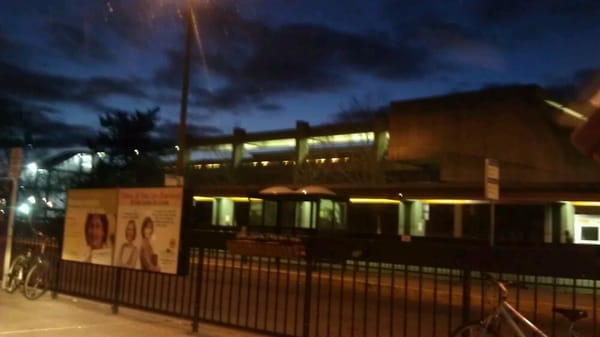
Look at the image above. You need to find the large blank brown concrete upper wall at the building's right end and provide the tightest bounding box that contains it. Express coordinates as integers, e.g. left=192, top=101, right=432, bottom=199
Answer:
left=388, top=87, right=600, bottom=182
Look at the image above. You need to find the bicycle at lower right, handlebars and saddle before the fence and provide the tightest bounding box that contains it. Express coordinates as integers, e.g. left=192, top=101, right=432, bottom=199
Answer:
left=450, top=274, right=587, bottom=337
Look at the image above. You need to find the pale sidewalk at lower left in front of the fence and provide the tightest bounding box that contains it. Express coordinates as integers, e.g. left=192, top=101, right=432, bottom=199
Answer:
left=0, top=289, right=262, bottom=337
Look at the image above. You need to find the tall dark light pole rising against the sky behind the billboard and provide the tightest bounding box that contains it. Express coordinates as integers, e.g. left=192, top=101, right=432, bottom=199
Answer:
left=176, top=0, right=193, bottom=177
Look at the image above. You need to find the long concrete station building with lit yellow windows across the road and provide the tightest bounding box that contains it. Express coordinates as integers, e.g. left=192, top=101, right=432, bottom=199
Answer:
left=186, top=86, right=600, bottom=244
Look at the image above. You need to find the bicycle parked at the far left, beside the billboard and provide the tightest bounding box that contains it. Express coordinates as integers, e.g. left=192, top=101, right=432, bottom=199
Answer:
left=4, top=232, right=51, bottom=300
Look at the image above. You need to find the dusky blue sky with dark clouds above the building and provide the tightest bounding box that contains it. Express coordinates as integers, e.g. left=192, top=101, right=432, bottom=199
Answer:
left=0, top=0, right=600, bottom=144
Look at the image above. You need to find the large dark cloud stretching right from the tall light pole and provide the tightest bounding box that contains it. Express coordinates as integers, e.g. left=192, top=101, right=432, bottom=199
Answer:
left=153, top=4, right=433, bottom=110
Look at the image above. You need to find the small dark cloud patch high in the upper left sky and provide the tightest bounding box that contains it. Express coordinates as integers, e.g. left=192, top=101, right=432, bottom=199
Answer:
left=48, top=22, right=116, bottom=62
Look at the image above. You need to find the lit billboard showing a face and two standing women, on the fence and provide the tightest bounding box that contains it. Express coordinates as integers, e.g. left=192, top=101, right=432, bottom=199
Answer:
left=62, top=187, right=183, bottom=274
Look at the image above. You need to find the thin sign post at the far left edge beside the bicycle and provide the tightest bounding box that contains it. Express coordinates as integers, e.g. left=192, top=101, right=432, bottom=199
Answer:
left=2, top=147, right=23, bottom=287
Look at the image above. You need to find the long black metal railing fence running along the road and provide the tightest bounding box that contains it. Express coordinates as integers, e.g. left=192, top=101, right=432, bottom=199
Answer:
left=5, top=232, right=600, bottom=337
